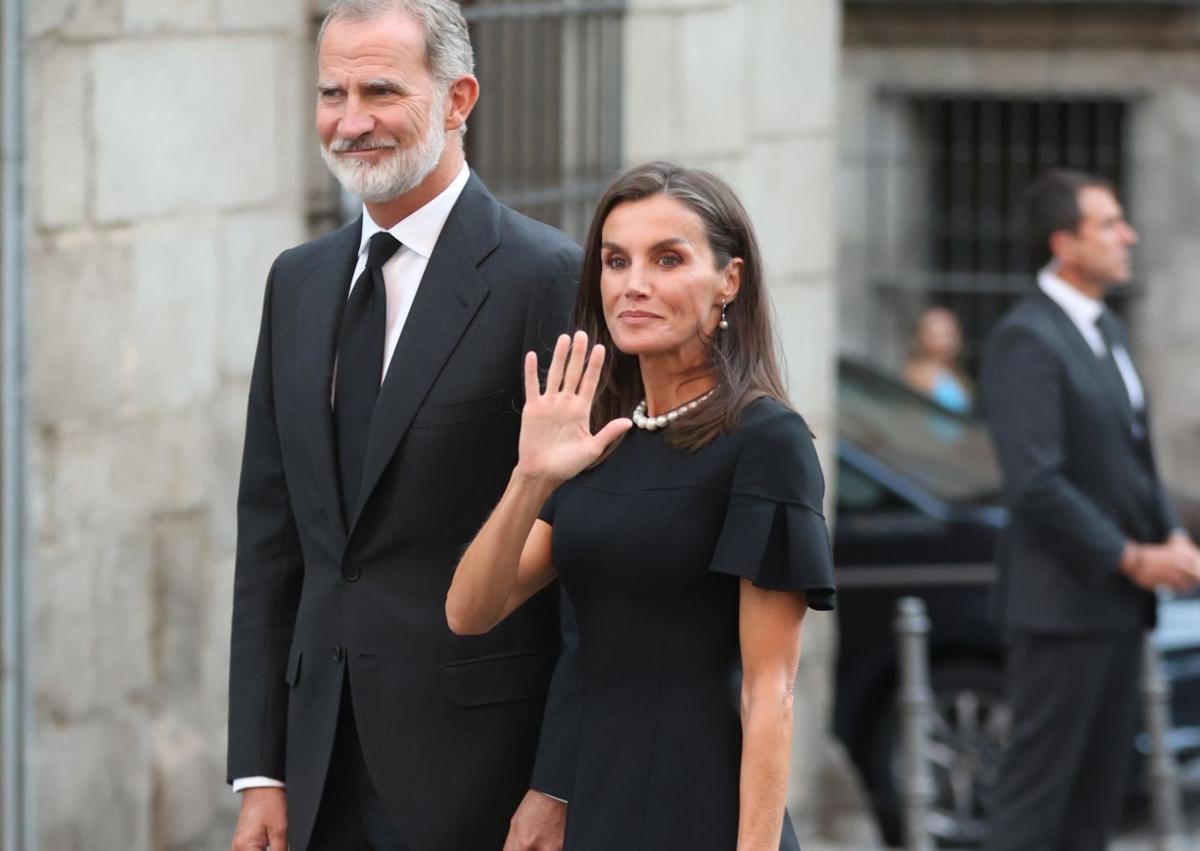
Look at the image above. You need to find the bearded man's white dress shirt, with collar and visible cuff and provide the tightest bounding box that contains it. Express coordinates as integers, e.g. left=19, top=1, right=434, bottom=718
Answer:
left=233, top=163, right=470, bottom=792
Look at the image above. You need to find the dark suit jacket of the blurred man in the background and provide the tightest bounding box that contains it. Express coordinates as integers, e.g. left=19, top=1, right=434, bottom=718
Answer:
left=980, top=290, right=1178, bottom=634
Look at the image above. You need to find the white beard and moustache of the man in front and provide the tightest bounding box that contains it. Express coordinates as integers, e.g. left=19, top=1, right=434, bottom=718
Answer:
left=320, top=106, right=446, bottom=203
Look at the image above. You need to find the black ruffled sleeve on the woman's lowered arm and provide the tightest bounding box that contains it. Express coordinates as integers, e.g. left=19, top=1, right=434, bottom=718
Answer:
left=709, top=403, right=835, bottom=610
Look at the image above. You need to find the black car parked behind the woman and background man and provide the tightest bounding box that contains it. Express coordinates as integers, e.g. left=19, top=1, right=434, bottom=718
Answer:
left=834, top=360, right=1200, bottom=846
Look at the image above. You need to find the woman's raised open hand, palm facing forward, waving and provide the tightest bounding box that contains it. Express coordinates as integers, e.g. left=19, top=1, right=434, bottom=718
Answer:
left=517, top=331, right=632, bottom=485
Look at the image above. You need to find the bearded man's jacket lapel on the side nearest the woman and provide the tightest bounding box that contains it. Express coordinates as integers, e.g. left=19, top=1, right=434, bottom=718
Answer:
left=350, top=174, right=500, bottom=534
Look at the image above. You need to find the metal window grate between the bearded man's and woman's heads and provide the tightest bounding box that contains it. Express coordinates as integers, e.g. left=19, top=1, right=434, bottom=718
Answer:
left=463, top=0, right=625, bottom=240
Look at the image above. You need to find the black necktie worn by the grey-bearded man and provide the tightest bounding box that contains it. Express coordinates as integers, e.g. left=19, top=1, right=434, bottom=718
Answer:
left=334, top=230, right=400, bottom=525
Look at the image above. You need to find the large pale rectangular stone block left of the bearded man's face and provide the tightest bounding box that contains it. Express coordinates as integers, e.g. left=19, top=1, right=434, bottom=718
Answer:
left=92, top=37, right=280, bottom=222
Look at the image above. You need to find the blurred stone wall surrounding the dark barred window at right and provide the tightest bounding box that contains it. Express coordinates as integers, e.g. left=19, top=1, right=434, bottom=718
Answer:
left=839, top=4, right=1200, bottom=495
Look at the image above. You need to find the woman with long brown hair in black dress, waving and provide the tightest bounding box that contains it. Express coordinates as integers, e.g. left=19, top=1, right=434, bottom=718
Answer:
left=446, top=163, right=833, bottom=851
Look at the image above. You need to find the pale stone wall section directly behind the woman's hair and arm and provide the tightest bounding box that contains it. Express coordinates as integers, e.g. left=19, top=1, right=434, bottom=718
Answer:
left=624, top=0, right=878, bottom=839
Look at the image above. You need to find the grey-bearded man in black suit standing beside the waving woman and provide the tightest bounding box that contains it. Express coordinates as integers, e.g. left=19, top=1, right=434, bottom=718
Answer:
left=228, top=0, right=580, bottom=851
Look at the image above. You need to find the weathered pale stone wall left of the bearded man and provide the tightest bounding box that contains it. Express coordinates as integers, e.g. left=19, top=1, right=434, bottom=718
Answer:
left=26, top=0, right=310, bottom=851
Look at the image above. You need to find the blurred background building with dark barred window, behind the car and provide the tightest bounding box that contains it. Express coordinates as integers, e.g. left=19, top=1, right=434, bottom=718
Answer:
left=839, top=0, right=1200, bottom=492
